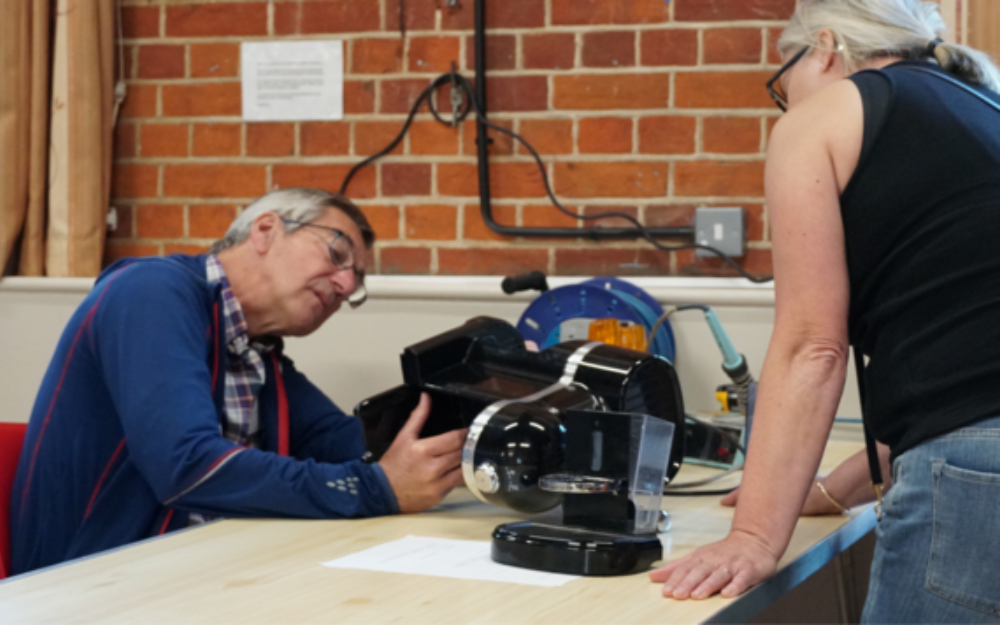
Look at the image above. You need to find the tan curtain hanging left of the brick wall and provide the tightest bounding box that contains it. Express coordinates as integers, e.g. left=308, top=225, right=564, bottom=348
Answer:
left=0, top=0, right=115, bottom=276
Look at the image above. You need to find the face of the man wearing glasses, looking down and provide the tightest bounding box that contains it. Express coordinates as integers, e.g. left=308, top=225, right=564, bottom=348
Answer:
left=268, top=208, right=368, bottom=336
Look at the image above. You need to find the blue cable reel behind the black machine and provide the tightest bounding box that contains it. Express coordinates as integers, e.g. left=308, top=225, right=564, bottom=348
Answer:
left=517, top=276, right=676, bottom=363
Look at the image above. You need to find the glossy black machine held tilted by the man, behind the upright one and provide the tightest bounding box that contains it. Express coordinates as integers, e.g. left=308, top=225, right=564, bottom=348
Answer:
left=354, top=317, right=684, bottom=479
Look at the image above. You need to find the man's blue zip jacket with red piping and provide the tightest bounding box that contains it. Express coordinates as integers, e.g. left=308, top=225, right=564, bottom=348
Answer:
left=11, top=255, right=397, bottom=574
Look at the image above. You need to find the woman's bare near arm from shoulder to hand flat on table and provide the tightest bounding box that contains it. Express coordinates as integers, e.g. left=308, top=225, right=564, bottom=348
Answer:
left=650, top=81, right=863, bottom=599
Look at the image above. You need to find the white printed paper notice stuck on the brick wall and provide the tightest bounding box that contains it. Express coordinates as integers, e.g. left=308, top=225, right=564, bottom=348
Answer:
left=240, top=41, right=344, bottom=121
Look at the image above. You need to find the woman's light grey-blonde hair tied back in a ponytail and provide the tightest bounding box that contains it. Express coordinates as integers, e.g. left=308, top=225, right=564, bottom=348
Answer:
left=778, top=0, right=1000, bottom=92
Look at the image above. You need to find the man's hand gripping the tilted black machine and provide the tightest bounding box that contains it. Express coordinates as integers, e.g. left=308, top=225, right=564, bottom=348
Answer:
left=379, top=393, right=468, bottom=512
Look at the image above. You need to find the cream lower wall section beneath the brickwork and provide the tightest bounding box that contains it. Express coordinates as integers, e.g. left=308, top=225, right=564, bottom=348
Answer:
left=0, top=276, right=860, bottom=421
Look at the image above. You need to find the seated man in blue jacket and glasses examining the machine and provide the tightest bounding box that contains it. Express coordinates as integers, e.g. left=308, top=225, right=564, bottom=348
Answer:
left=11, top=189, right=465, bottom=573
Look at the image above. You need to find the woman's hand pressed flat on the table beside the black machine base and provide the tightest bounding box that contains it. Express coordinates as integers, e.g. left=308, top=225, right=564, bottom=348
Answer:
left=649, top=532, right=778, bottom=599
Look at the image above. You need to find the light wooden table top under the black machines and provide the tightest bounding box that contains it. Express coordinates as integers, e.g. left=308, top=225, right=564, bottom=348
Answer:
left=0, top=442, right=875, bottom=624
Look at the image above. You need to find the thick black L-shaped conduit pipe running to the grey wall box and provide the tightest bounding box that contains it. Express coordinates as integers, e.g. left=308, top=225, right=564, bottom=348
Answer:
left=473, top=0, right=694, bottom=241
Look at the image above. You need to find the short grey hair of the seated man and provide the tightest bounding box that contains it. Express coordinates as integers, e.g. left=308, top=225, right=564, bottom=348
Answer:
left=208, top=187, right=375, bottom=254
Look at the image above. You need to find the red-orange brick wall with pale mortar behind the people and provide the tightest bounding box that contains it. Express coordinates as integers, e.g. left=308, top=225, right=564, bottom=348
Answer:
left=107, top=0, right=795, bottom=276
